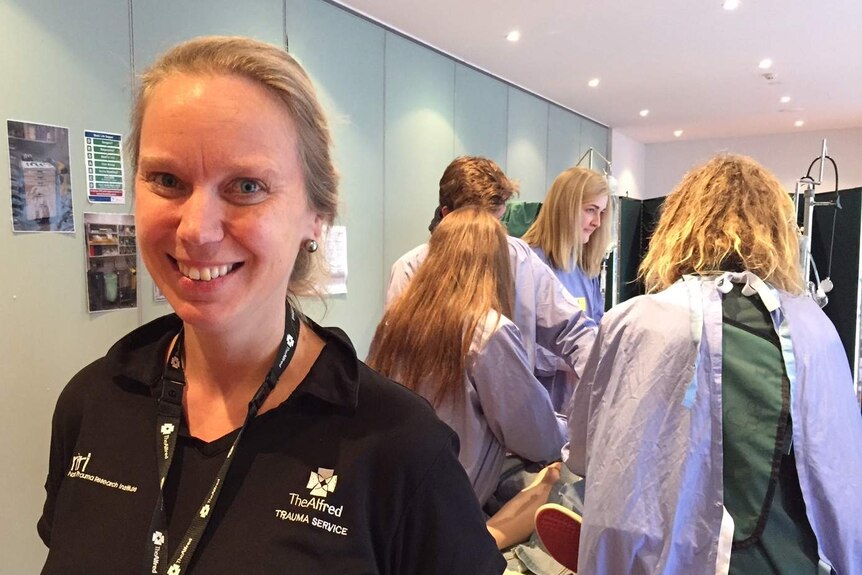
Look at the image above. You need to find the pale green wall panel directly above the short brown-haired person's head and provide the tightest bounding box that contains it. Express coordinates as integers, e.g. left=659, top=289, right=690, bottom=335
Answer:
left=455, top=64, right=509, bottom=171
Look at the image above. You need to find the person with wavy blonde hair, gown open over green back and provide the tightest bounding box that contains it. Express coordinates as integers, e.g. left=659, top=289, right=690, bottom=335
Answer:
left=552, top=155, right=862, bottom=575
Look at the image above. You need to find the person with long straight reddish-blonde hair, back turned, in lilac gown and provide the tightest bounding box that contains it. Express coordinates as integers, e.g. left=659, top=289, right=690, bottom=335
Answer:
left=368, top=207, right=566, bottom=536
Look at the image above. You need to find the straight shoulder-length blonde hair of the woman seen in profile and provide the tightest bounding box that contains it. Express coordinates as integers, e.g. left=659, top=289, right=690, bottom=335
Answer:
left=521, top=168, right=613, bottom=277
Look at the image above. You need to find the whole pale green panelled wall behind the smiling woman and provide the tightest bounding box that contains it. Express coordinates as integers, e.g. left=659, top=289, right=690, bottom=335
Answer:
left=0, top=0, right=610, bottom=573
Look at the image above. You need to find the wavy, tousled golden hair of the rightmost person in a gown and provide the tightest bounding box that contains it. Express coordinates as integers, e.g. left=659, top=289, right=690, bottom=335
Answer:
left=640, top=155, right=803, bottom=294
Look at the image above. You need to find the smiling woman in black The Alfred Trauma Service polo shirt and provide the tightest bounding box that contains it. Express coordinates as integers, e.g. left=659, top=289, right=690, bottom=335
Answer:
left=38, top=37, right=505, bottom=575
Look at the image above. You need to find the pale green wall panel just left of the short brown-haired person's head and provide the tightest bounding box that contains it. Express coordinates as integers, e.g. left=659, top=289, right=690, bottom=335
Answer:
left=383, top=32, right=455, bottom=270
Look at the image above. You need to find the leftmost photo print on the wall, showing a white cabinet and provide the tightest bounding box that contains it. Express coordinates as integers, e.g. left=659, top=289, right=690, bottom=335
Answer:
left=6, top=120, right=75, bottom=233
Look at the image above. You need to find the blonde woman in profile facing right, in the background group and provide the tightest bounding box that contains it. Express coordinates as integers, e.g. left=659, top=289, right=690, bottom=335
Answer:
left=521, top=167, right=613, bottom=412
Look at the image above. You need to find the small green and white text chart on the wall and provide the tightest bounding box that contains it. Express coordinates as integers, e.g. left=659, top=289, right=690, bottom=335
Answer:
left=84, top=130, right=126, bottom=204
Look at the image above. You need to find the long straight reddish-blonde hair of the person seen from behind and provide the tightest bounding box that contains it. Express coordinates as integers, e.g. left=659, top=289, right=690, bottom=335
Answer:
left=368, top=206, right=514, bottom=407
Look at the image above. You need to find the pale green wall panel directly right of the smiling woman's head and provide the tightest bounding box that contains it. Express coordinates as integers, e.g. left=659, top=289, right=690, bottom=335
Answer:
left=286, top=0, right=384, bottom=357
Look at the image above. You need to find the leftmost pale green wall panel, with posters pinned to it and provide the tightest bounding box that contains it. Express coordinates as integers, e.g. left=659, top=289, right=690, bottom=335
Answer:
left=0, top=0, right=133, bottom=574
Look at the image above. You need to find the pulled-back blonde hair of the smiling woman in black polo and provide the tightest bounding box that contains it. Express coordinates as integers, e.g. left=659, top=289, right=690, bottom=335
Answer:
left=126, top=36, right=338, bottom=295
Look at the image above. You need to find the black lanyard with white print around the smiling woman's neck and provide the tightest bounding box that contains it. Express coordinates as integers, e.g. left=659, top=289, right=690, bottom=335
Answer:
left=144, top=304, right=299, bottom=575
